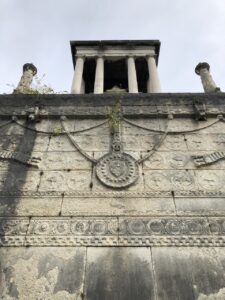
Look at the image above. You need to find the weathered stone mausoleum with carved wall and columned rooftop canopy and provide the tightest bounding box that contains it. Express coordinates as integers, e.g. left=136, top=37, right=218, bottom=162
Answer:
left=0, top=40, right=225, bottom=300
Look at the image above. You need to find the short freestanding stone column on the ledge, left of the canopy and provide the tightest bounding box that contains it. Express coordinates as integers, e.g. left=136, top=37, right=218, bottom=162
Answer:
left=14, top=63, right=37, bottom=94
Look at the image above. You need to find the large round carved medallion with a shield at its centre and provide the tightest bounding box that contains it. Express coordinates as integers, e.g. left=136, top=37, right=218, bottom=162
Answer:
left=96, top=152, right=138, bottom=188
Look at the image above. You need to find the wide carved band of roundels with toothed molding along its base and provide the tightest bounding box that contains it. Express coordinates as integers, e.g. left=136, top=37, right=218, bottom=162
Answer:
left=0, top=217, right=225, bottom=247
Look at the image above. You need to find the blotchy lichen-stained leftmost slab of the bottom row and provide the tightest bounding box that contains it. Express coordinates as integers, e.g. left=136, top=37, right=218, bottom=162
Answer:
left=0, top=248, right=84, bottom=300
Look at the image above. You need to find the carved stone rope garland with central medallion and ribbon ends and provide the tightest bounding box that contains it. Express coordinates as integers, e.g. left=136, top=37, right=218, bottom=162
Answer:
left=0, top=111, right=225, bottom=188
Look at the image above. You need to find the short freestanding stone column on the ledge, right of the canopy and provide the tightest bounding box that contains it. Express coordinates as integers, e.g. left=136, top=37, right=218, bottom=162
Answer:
left=195, top=62, right=220, bottom=93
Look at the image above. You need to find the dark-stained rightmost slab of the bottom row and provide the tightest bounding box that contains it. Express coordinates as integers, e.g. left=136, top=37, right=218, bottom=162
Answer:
left=153, top=248, right=225, bottom=300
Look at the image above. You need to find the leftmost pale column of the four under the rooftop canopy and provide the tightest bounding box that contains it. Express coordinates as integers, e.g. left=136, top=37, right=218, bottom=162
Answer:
left=71, top=56, right=85, bottom=94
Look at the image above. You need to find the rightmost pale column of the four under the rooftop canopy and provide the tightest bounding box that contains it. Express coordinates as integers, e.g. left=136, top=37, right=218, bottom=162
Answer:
left=147, top=56, right=161, bottom=93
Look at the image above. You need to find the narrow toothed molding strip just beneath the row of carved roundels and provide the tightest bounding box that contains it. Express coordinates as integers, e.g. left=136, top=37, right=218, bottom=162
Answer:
left=0, top=236, right=225, bottom=247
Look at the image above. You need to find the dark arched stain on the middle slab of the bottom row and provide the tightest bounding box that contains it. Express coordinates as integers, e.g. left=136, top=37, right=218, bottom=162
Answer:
left=85, top=248, right=155, bottom=300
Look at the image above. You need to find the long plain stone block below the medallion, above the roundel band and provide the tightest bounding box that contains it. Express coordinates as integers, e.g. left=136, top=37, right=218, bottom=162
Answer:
left=62, top=197, right=175, bottom=216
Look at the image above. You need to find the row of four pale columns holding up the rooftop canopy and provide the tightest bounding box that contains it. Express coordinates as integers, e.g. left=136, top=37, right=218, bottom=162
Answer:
left=71, top=56, right=161, bottom=94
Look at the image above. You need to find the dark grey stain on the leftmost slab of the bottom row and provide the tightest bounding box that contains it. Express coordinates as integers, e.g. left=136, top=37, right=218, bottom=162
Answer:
left=38, top=250, right=84, bottom=294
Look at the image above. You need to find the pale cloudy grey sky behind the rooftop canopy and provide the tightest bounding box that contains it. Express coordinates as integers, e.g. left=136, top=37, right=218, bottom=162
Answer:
left=0, top=0, right=225, bottom=93
